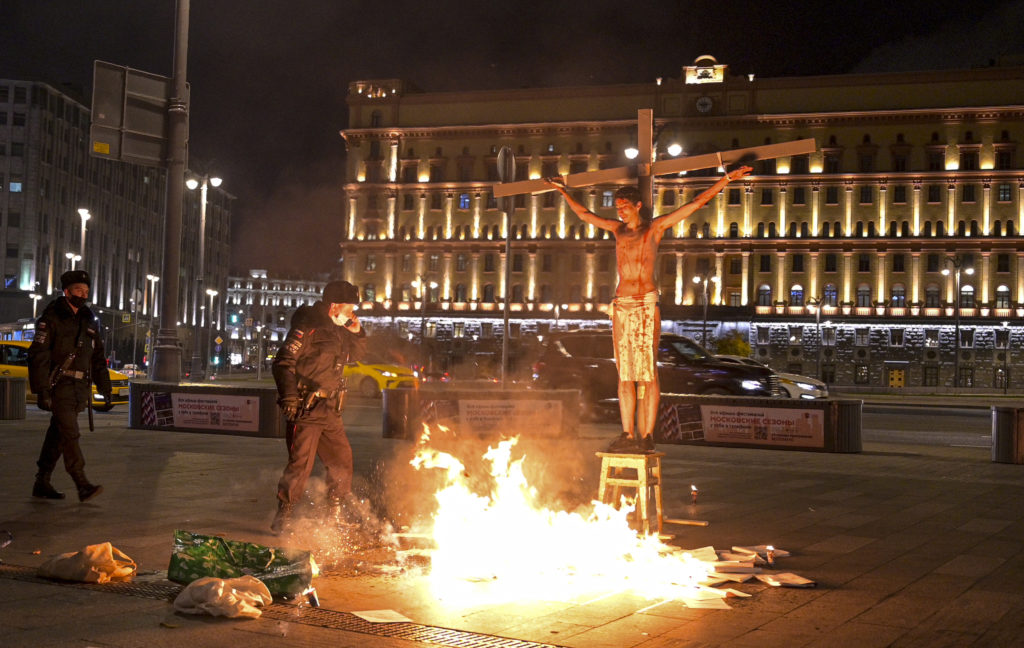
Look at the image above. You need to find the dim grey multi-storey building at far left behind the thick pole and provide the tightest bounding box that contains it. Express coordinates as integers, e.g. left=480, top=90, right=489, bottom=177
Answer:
left=0, top=79, right=233, bottom=359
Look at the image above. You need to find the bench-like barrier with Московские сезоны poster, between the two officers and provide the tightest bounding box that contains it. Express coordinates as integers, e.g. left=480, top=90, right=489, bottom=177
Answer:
left=128, top=381, right=285, bottom=438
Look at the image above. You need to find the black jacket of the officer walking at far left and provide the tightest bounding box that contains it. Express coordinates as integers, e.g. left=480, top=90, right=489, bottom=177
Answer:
left=29, top=296, right=111, bottom=397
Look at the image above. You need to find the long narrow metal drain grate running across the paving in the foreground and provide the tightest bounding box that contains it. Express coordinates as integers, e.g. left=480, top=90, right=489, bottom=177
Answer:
left=0, top=563, right=559, bottom=648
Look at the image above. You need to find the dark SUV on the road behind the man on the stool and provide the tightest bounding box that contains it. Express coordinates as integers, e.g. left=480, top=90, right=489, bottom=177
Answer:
left=534, top=330, right=781, bottom=417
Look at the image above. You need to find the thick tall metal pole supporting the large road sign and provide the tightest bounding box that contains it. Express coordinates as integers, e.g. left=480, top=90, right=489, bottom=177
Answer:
left=153, top=0, right=189, bottom=383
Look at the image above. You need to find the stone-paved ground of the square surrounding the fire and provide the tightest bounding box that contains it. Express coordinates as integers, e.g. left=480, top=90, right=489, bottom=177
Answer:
left=0, top=401, right=1024, bottom=648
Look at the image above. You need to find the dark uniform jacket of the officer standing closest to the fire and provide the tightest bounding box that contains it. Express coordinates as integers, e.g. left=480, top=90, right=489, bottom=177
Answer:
left=273, top=302, right=367, bottom=400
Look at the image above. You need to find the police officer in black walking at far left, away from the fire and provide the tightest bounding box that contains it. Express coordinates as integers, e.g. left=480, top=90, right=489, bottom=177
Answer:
left=29, top=270, right=111, bottom=502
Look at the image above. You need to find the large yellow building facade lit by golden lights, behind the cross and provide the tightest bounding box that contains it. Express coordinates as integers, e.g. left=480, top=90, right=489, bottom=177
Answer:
left=341, top=56, right=1024, bottom=390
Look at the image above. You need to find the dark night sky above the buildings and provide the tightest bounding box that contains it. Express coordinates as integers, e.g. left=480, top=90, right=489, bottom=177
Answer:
left=0, top=0, right=1024, bottom=275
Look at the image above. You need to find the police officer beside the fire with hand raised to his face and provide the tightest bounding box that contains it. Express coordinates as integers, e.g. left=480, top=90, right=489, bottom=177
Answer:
left=270, top=282, right=367, bottom=533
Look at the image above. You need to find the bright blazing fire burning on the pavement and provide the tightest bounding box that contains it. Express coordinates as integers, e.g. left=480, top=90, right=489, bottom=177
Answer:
left=412, top=429, right=724, bottom=604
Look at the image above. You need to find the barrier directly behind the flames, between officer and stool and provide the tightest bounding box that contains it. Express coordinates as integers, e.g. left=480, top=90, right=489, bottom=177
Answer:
left=383, top=387, right=580, bottom=439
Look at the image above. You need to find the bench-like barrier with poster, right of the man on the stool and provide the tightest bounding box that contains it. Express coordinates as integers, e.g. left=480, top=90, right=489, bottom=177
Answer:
left=654, top=394, right=863, bottom=452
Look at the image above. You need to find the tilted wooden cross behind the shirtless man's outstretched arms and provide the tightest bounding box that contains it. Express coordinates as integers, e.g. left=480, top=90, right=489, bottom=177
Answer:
left=494, top=109, right=817, bottom=207
